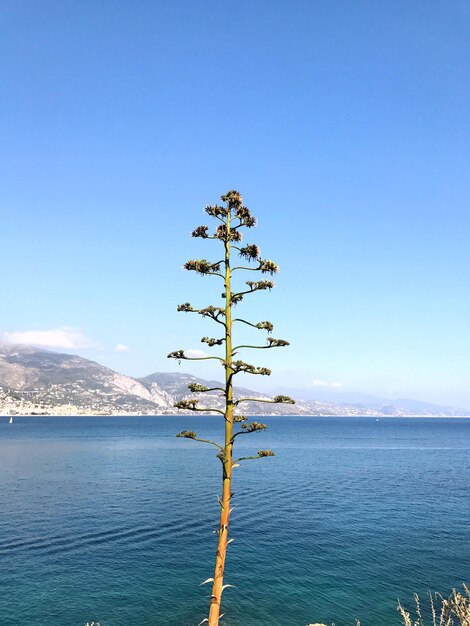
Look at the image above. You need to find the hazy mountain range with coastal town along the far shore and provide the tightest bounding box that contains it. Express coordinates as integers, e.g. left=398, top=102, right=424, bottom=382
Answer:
left=0, top=345, right=470, bottom=417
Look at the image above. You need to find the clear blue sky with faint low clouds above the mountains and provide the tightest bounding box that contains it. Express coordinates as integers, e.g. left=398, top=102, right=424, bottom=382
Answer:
left=0, top=0, right=470, bottom=407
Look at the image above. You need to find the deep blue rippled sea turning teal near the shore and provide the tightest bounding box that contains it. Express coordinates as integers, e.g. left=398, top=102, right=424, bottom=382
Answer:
left=0, top=416, right=470, bottom=626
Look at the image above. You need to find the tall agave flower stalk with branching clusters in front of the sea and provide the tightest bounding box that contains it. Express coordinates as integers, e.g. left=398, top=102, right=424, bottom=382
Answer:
left=168, top=191, right=294, bottom=626
